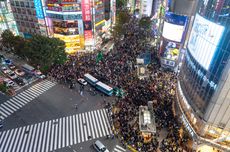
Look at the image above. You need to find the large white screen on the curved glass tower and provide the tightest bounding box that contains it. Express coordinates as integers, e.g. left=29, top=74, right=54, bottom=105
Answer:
left=188, top=14, right=224, bottom=70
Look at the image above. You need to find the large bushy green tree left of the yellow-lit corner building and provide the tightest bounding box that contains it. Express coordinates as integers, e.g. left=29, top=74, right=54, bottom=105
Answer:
left=25, top=35, right=67, bottom=67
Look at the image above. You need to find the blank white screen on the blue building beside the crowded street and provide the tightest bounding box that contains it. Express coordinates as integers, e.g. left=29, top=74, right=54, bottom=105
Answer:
left=162, top=21, right=185, bottom=42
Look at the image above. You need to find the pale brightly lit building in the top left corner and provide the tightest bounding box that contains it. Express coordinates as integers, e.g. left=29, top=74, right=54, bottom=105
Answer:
left=0, top=1, right=18, bottom=35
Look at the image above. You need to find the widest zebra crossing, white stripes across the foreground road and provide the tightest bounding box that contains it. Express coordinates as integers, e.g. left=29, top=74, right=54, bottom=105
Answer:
left=0, top=109, right=112, bottom=152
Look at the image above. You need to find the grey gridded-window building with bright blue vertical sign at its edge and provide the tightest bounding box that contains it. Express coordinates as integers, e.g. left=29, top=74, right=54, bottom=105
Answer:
left=10, top=0, right=47, bottom=38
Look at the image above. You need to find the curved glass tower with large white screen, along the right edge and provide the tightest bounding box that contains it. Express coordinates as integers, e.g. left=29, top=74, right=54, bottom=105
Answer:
left=177, top=0, right=230, bottom=151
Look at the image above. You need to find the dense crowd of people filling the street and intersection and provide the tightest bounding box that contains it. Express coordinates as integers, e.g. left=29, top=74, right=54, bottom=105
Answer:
left=49, top=13, right=190, bottom=152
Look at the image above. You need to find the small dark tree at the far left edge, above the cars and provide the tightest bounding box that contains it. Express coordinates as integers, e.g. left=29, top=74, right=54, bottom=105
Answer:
left=1, top=29, right=14, bottom=50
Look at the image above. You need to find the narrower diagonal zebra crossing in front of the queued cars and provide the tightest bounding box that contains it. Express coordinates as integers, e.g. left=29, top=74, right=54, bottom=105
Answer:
left=0, top=80, right=56, bottom=120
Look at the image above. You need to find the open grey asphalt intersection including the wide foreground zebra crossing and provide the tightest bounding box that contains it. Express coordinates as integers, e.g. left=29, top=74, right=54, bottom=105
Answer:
left=0, top=79, right=127, bottom=152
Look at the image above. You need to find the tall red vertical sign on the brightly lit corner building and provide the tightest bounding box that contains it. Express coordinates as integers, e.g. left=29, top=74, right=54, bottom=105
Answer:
left=81, top=0, right=93, bottom=45
